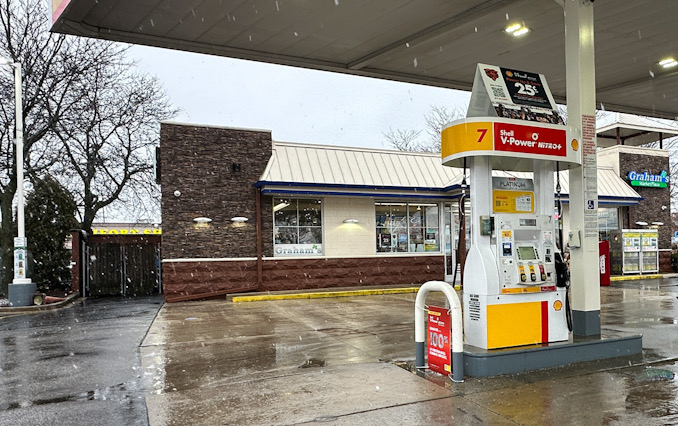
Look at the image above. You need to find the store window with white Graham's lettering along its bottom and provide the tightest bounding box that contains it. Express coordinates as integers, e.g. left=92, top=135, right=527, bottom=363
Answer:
left=273, top=198, right=323, bottom=256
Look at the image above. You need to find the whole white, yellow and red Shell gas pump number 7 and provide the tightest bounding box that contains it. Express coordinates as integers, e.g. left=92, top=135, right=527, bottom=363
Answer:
left=442, top=64, right=580, bottom=349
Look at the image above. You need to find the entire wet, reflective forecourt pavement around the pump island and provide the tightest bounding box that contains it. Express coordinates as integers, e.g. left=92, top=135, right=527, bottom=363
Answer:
left=0, top=278, right=678, bottom=425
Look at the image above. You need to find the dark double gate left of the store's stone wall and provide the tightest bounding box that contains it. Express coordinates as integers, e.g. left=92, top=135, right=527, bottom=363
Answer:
left=87, top=242, right=160, bottom=296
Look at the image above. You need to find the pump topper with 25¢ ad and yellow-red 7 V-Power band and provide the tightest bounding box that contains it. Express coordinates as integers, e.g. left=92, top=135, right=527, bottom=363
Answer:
left=441, top=64, right=582, bottom=171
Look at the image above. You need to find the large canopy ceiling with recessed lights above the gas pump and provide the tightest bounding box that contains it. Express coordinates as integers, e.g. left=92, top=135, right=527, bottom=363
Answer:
left=52, top=0, right=678, bottom=119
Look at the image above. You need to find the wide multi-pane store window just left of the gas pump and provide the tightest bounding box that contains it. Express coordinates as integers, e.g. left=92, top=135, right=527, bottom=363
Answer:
left=375, top=202, right=440, bottom=253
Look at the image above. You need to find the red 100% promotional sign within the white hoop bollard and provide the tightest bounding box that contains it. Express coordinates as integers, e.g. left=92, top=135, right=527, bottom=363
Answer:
left=428, top=306, right=452, bottom=376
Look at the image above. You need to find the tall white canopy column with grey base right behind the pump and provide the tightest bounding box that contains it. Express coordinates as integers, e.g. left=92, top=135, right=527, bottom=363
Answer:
left=563, top=0, right=600, bottom=336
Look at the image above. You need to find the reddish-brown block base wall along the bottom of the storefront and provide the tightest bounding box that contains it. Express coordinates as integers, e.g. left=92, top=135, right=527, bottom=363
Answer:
left=163, top=255, right=445, bottom=298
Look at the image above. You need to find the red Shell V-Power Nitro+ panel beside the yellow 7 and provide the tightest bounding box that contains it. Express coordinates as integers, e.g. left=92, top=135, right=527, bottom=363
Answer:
left=494, top=122, right=567, bottom=157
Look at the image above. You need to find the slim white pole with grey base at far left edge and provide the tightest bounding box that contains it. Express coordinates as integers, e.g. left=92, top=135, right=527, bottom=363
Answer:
left=0, top=57, right=35, bottom=306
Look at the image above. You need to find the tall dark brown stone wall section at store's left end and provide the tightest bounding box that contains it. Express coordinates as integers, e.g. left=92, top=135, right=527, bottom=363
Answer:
left=160, top=123, right=273, bottom=260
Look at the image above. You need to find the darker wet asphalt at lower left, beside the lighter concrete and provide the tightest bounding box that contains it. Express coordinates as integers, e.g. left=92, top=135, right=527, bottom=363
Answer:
left=0, top=297, right=163, bottom=425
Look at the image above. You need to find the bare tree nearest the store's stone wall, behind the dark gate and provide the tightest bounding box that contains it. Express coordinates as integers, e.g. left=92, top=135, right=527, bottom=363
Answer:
left=55, top=62, right=176, bottom=232
